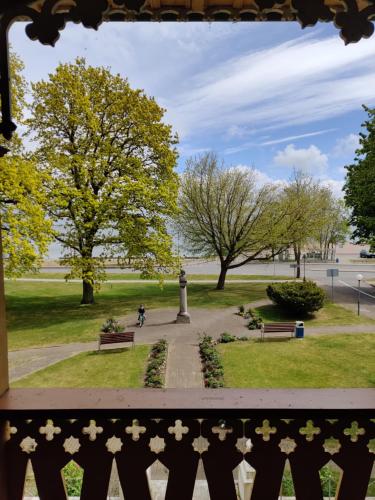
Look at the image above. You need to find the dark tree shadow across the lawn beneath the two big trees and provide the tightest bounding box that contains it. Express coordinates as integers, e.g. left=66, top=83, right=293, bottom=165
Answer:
left=6, top=282, right=265, bottom=332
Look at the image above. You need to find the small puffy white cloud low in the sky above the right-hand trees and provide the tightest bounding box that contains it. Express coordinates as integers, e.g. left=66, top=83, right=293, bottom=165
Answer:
left=273, top=144, right=328, bottom=175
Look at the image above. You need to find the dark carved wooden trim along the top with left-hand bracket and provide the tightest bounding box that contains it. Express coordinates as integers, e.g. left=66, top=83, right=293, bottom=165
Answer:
left=0, top=0, right=375, bottom=145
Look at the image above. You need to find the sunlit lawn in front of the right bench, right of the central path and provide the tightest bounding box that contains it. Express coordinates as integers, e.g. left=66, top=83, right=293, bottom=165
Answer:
left=217, top=334, right=375, bottom=388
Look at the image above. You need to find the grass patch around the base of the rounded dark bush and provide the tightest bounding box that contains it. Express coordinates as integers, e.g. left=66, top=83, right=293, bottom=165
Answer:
left=256, top=300, right=375, bottom=326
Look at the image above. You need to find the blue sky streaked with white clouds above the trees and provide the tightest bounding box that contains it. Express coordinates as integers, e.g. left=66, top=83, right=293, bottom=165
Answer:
left=10, top=23, right=375, bottom=201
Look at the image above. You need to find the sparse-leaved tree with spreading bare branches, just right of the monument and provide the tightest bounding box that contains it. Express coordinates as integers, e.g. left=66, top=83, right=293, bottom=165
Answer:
left=178, top=153, right=289, bottom=290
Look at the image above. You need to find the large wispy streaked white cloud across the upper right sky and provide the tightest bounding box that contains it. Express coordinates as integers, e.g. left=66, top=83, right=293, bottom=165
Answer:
left=168, top=37, right=375, bottom=138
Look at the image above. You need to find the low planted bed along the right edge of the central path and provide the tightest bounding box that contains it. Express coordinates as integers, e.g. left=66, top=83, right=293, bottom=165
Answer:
left=199, top=334, right=225, bottom=389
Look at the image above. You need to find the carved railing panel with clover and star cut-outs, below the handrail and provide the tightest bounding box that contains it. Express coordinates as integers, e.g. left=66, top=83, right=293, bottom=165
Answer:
left=4, top=410, right=375, bottom=500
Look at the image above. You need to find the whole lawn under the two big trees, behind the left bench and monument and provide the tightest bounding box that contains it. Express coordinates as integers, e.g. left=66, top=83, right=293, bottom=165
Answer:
left=5, top=281, right=266, bottom=350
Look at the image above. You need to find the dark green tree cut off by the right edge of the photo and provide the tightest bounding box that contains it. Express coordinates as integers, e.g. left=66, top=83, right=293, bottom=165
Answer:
left=344, top=106, right=375, bottom=245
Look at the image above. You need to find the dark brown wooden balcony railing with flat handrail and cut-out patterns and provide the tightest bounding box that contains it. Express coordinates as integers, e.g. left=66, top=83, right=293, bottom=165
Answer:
left=0, top=389, right=375, bottom=500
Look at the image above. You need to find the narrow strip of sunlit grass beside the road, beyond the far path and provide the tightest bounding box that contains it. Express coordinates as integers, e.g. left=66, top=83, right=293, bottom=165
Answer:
left=22, top=271, right=293, bottom=281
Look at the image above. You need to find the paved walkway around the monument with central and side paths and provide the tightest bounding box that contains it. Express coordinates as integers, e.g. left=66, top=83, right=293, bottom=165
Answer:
left=9, top=300, right=375, bottom=382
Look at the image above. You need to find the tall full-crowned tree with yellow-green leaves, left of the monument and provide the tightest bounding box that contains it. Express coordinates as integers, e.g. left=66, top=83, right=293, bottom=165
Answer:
left=28, top=59, right=178, bottom=304
